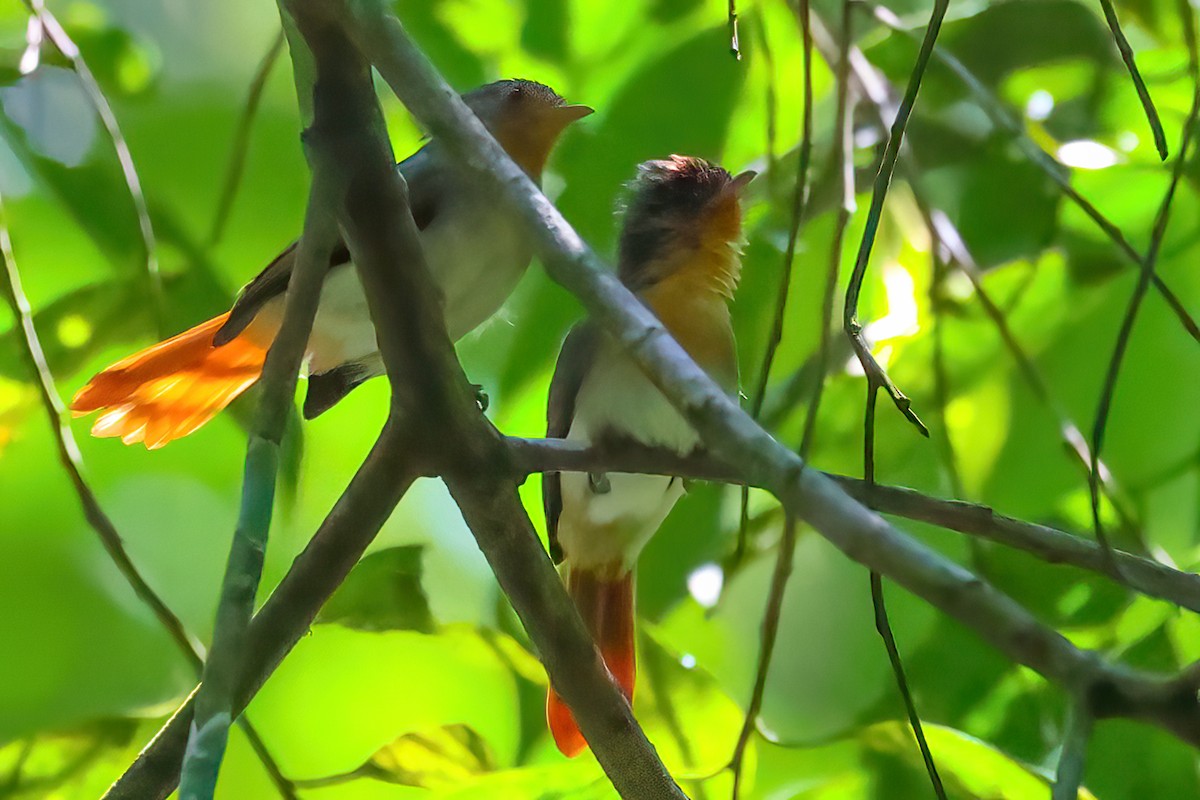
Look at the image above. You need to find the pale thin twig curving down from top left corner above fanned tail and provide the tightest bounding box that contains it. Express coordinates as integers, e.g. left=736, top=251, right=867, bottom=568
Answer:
left=24, top=0, right=166, bottom=332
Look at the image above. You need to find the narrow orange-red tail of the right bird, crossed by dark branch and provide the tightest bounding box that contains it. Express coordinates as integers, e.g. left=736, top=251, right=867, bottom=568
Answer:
left=546, top=570, right=637, bottom=758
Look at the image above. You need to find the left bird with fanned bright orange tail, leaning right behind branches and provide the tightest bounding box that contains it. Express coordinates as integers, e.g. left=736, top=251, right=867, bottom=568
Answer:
left=71, top=80, right=592, bottom=450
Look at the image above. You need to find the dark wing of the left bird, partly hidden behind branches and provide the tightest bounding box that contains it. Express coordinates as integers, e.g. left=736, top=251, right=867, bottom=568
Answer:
left=212, top=146, right=443, bottom=347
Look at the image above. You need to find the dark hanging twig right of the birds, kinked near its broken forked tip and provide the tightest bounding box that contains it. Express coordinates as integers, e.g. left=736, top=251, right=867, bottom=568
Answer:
left=842, top=0, right=949, bottom=438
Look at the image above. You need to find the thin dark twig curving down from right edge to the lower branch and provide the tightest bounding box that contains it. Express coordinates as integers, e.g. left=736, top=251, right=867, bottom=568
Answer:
left=1087, top=86, right=1200, bottom=568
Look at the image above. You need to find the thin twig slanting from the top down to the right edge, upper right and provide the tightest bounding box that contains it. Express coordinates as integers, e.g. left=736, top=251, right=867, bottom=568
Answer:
left=854, top=0, right=1200, bottom=342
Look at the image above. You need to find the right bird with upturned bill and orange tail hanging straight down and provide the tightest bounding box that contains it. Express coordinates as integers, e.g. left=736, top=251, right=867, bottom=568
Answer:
left=542, top=156, right=755, bottom=756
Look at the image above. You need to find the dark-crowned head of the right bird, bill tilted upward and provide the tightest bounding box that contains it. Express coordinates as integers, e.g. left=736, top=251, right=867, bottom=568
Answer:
left=618, top=156, right=756, bottom=294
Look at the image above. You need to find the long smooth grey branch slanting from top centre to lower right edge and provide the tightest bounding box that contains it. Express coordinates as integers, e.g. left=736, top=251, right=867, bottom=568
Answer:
left=344, top=0, right=1200, bottom=745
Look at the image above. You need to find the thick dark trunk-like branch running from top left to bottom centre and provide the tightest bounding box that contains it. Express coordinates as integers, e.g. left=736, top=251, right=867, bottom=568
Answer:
left=284, top=2, right=684, bottom=800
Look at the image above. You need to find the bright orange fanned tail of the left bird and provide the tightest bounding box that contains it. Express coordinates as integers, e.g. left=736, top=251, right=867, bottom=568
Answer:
left=71, top=314, right=266, bottom=450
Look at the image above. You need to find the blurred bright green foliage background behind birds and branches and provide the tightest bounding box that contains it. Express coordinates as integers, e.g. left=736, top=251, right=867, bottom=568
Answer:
left=0, top=0, right=1200, bottom=800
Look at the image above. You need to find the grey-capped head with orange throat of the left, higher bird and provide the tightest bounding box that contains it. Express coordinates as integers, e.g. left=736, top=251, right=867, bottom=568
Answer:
left=463, top=78, right=593, bottom=180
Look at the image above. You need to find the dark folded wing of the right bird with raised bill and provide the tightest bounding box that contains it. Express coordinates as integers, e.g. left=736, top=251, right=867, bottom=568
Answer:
left=541, top=323, right=601, bottom=564
